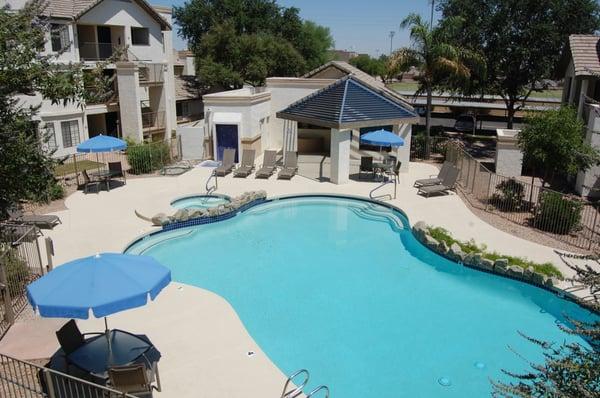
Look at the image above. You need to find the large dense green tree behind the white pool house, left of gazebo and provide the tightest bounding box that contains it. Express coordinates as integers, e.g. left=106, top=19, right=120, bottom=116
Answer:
left=173, top=0, right=333, bottom=89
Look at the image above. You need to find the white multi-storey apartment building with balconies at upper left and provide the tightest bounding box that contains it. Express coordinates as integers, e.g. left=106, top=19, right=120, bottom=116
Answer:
left=8, top=0, right=177, bottom=157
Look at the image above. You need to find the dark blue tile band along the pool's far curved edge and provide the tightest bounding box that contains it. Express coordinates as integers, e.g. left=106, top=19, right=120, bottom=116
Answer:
left=122, top=193, right=600, bottom=316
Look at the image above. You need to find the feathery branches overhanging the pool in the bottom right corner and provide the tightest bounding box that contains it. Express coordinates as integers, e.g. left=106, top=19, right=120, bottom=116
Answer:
left=492, top=265, right=600, bottom=398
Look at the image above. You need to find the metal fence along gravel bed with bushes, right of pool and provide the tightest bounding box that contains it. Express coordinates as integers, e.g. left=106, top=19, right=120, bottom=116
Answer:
left=446, top=143, right=600, bottom=251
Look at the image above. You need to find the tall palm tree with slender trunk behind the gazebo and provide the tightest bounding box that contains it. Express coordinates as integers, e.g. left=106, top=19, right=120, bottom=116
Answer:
left=388, top=14, right=483, bottom=157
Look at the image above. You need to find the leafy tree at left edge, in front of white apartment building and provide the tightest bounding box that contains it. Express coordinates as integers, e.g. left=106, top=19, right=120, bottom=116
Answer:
left=0, top=0, right=122, bottom=220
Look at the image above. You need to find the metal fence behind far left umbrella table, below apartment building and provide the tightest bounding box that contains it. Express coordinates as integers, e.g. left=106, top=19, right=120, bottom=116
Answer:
left=54, top=137, right=181, bottom=185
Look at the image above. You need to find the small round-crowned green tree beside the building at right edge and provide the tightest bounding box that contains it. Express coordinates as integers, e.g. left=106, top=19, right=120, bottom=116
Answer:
left=518, top=106, right=600, bottom=187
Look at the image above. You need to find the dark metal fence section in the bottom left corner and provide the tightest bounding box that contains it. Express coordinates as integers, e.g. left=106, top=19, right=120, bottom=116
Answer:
left=0, top=354, right=134, bottom=398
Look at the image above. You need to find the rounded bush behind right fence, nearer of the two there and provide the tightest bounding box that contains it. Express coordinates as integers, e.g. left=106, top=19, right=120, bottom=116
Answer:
left=533, top=191, right=583, bottom=235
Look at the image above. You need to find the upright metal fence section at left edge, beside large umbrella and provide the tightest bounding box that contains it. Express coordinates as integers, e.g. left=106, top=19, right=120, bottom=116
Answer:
left=0, top=223, right=45, bottom=337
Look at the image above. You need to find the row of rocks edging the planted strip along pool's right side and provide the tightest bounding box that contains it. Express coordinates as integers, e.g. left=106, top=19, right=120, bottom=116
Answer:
left=412, top=221, right=565, bottom=294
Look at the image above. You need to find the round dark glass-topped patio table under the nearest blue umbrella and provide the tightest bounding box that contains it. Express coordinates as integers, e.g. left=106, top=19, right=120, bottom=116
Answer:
left=68, top=329, right=161, bottom=381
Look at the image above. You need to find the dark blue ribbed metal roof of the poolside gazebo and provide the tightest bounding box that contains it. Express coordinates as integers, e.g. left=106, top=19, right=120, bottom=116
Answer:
left=277, top=75, right=418, bottom=129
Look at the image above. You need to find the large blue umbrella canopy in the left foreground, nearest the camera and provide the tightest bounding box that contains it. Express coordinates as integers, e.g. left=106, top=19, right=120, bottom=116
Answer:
left=27, top=253, right=171, bottom=319
